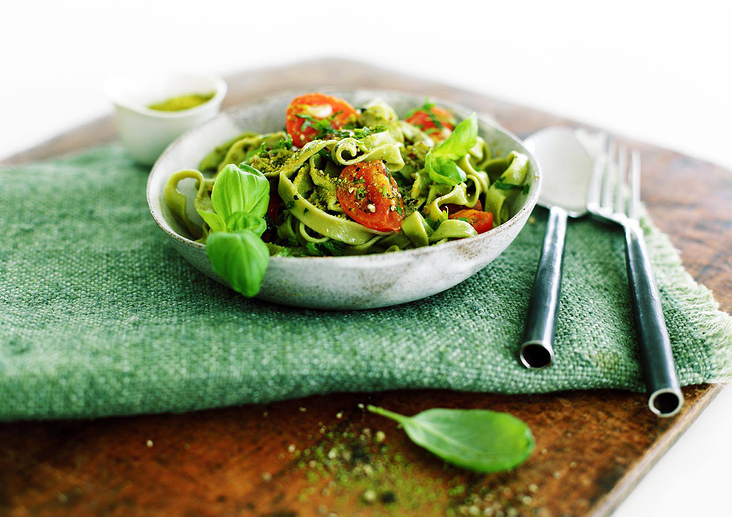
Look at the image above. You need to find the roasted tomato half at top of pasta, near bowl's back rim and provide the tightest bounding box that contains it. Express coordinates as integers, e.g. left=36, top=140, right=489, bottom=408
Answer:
left=285, top=93, right=358, bottom=147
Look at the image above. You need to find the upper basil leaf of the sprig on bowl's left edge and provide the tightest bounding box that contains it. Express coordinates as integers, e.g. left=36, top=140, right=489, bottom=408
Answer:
left=211, top=164, right=269, bottom=219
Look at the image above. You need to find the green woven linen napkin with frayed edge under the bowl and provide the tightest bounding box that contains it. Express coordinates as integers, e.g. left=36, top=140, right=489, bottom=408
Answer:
left=0, top=145, right=732, bottom=420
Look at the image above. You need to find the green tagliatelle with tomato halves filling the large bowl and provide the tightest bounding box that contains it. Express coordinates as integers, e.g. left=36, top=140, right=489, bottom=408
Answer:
left=165, top=94, right=529, bottom=258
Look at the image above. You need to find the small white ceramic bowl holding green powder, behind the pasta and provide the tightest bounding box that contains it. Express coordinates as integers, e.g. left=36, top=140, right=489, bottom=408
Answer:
left=104, top=73, right=226, bottom=165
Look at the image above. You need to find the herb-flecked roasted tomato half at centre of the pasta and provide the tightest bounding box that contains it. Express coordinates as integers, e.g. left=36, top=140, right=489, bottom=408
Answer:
left=336, top=161, right=404, bottom=232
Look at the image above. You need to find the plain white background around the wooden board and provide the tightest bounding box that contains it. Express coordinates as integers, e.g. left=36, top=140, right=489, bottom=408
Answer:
left=0, top=0, right=732, bottom=517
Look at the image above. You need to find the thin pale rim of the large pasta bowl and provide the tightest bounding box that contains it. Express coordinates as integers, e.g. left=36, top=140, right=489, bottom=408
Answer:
left=146, top=87, right=543, bottom=265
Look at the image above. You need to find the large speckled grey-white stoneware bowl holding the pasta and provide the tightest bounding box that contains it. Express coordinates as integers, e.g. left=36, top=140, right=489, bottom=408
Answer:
left=147, top=89, right=541, bottom=310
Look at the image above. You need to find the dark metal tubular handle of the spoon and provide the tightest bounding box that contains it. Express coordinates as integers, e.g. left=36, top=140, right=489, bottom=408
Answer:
left=519, top=206, right=567, bottom=369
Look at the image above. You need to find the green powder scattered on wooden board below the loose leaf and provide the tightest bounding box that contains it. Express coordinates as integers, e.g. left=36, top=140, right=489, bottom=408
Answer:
left=290, top=416, right=538, bottom=517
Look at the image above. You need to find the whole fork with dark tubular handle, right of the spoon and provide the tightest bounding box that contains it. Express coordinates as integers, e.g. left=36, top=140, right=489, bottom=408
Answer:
left=587, top=134, right=684, bottom=417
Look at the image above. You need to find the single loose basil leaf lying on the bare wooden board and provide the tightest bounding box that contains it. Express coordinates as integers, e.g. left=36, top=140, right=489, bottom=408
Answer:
left=368, top=406, right=535, bottom=473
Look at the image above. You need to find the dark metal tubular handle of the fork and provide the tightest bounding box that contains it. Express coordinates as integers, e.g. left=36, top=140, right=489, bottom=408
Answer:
left=624, top=223, right=684, bottom=417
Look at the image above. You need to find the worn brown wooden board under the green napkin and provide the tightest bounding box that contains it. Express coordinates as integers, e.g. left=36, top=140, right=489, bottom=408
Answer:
left=0, top=60, right=732, bottom=517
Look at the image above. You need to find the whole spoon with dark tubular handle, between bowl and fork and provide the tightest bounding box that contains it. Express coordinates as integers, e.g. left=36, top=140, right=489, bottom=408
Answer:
left=519, top=126, right=593, bottom=369
